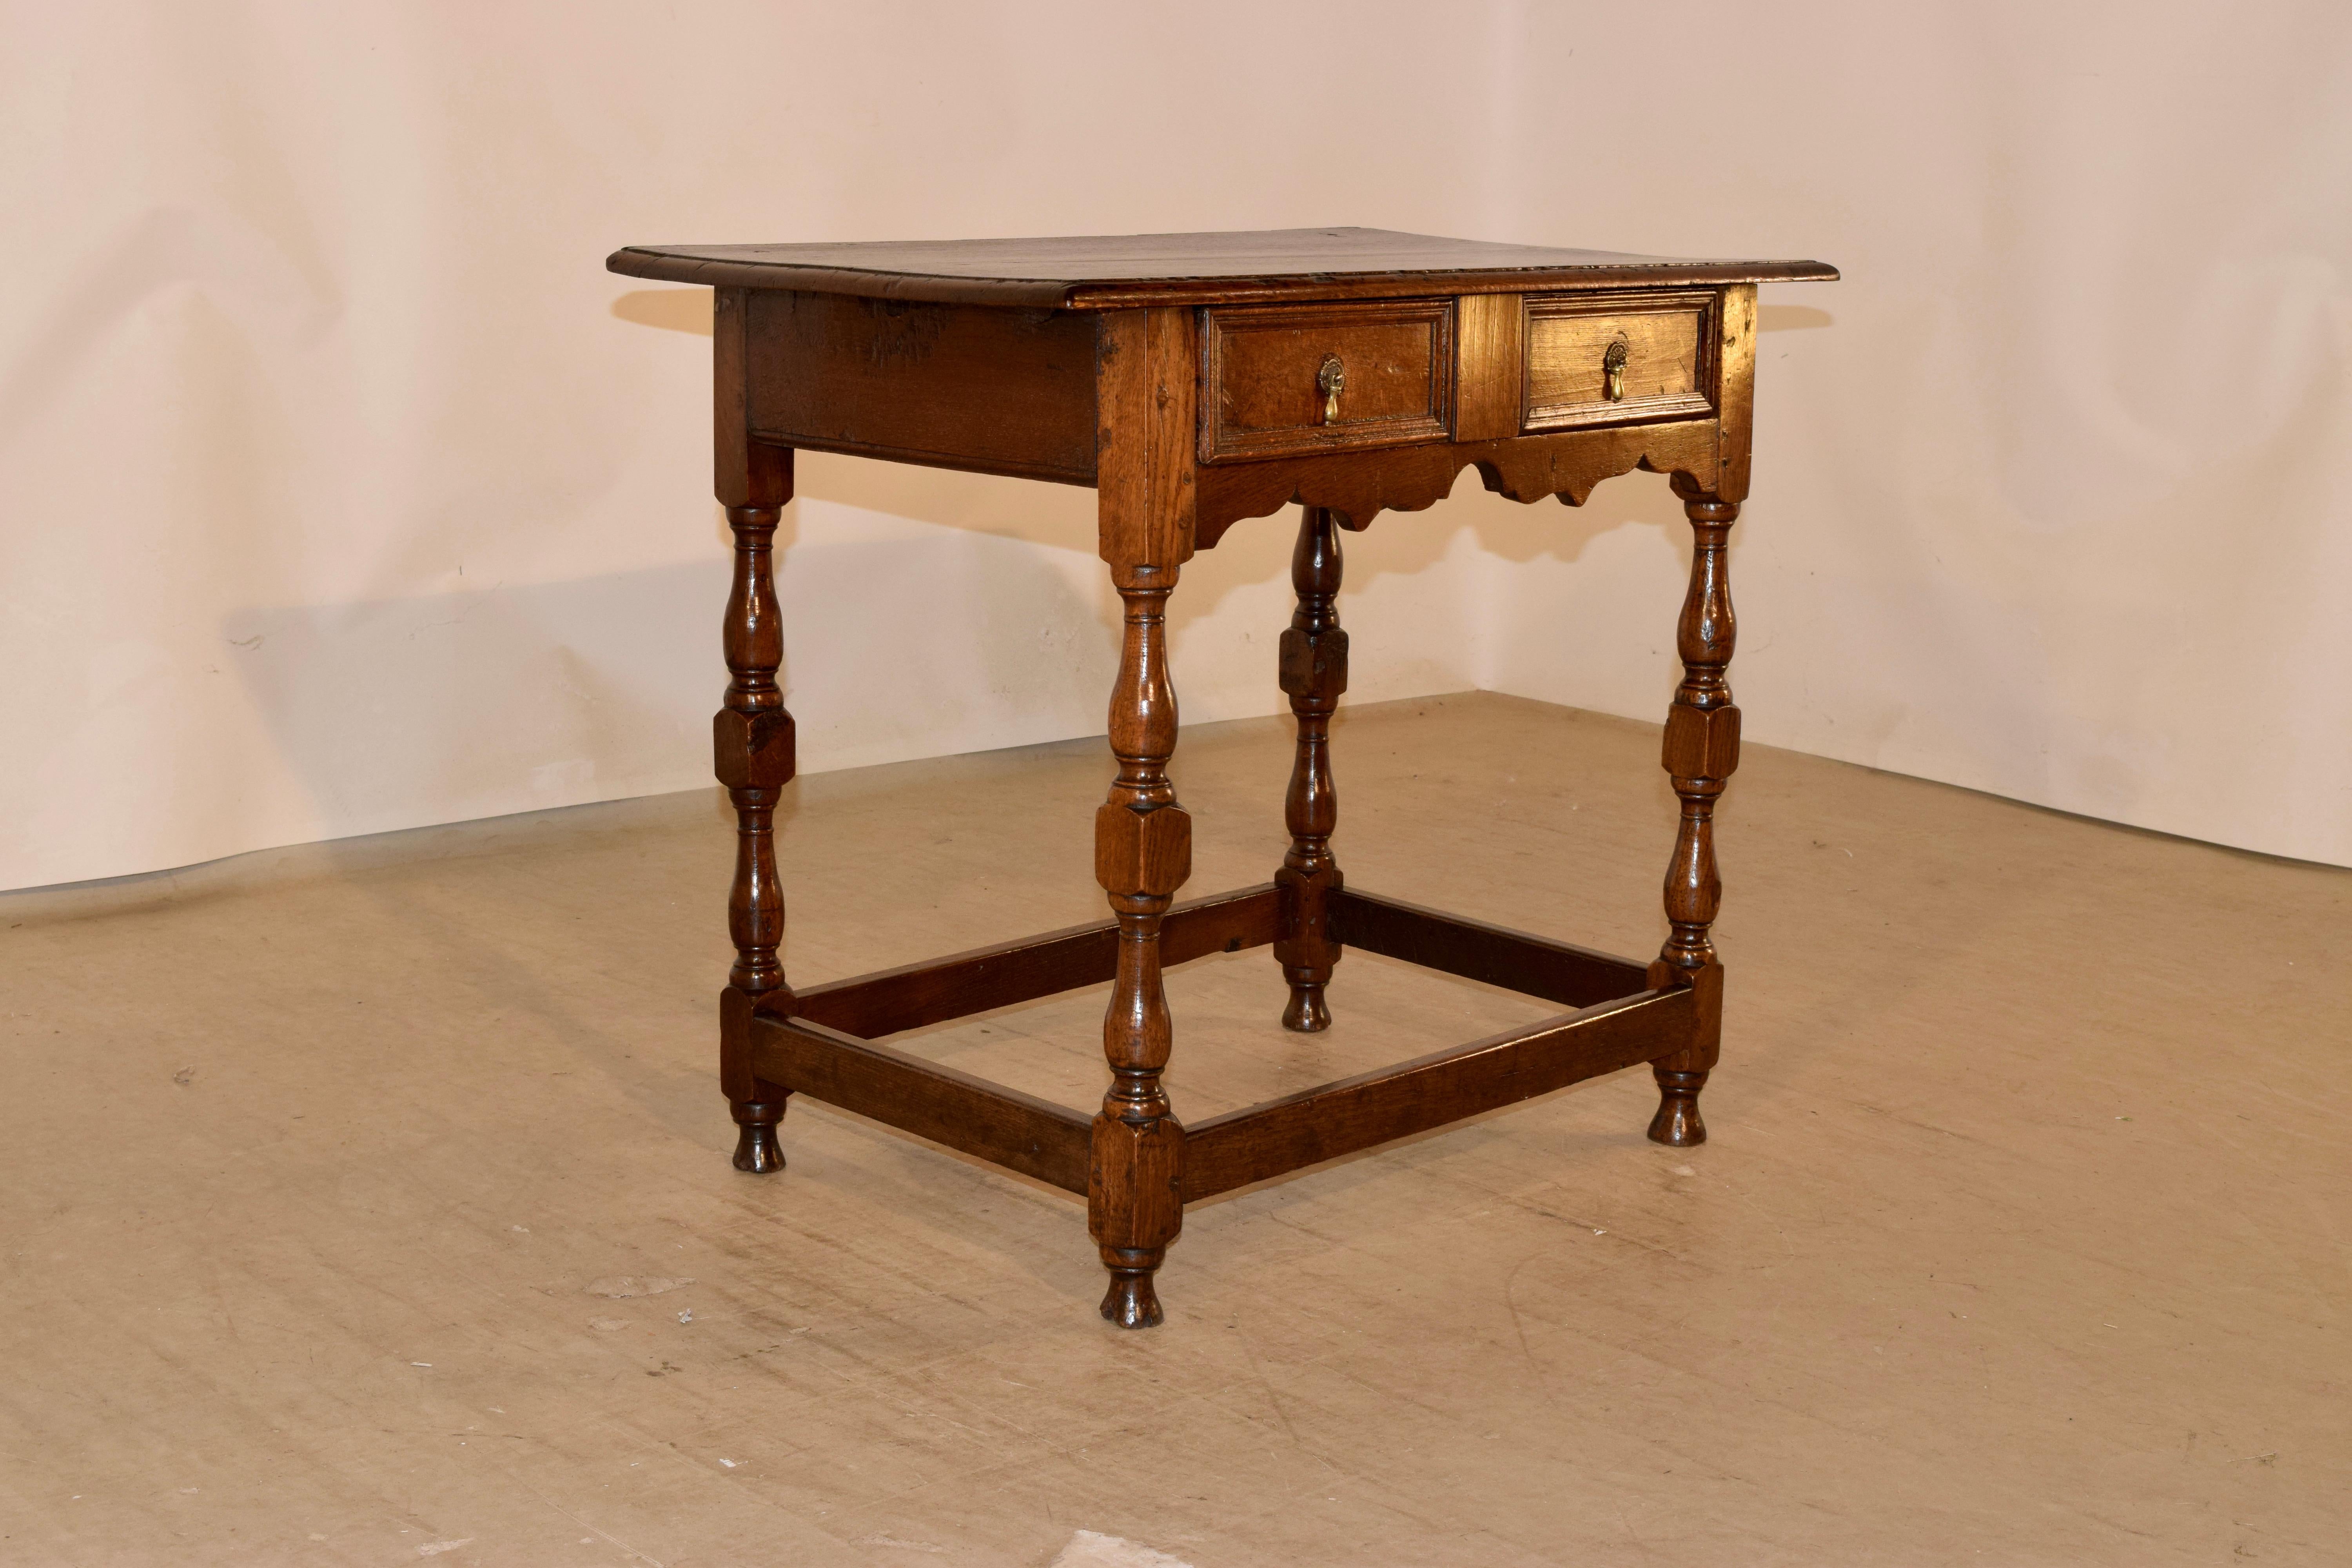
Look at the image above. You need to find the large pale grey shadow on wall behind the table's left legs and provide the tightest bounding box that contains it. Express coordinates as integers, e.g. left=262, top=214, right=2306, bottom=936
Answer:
left=221, top=534, right=1117, bottom=832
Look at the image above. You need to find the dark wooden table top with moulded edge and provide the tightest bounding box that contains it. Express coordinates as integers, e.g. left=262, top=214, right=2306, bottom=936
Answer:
left=604, top=228, right=1837, bottom=310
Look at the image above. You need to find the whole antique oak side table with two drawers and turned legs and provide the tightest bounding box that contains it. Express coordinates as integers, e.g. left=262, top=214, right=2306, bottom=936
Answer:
left=607, top=228, right=1837, bottom=1328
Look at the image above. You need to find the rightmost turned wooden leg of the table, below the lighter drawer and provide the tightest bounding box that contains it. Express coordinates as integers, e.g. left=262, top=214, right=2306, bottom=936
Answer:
left=1649, top=475, right=1740, bottom=1147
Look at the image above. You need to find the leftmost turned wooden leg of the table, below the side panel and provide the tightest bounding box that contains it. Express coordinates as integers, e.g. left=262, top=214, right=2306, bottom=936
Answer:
left=713, top=505, right=795, bottom=1173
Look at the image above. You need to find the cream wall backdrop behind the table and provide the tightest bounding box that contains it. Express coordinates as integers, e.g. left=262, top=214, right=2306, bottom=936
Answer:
left=0, top=0, right=2352, bottom=886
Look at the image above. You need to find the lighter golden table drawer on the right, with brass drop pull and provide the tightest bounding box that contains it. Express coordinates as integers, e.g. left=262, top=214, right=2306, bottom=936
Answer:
left=1519, top=292, right=1717, bottom=430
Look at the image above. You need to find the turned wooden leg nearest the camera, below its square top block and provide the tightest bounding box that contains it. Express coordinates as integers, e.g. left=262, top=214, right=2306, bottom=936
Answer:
left=1087, top=566, right=1192, bottom=1328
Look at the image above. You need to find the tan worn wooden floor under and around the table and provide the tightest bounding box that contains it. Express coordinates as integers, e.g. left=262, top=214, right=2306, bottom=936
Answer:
left=0, top=696, right=2352, bottom=1568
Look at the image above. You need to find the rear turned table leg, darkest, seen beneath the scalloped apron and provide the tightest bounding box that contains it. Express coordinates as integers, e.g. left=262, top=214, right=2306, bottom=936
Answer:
left=1275, top=505, right=1348, bottom=1034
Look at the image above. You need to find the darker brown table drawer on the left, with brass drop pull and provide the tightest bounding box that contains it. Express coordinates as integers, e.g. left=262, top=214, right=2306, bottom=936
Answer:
left=1200, top=299, right=1454, bottom=463
